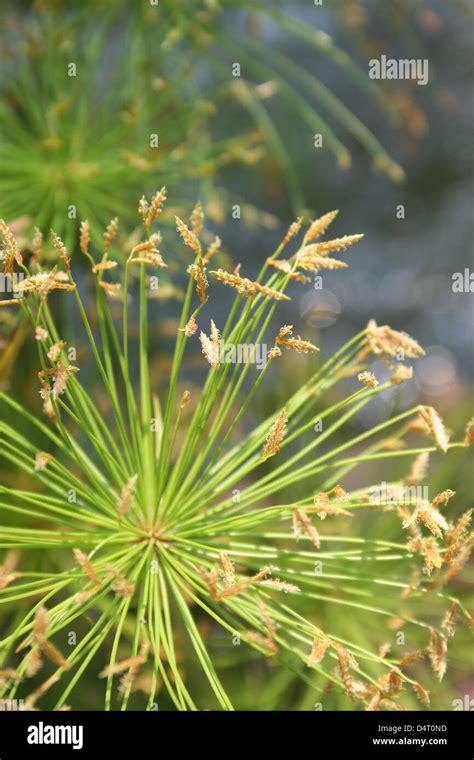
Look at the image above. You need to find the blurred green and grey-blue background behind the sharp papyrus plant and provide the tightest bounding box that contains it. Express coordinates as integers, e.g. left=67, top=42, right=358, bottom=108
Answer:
left=0, top=0, right=474, bottom=707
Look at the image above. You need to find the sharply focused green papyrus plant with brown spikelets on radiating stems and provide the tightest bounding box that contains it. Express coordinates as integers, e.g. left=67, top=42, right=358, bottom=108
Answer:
left=0, top=197, right=473, bottom=710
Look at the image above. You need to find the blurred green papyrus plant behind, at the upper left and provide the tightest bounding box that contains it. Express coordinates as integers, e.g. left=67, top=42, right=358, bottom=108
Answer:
left=0, top=0, right=418, bottom=246
